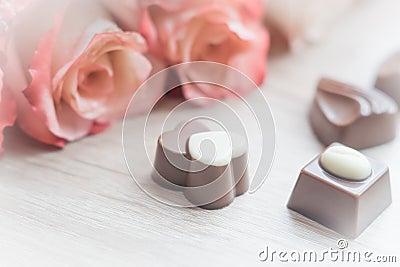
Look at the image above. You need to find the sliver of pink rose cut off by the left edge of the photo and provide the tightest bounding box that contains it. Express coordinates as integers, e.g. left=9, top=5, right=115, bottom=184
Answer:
left=0, top=69, right=17, bottom=153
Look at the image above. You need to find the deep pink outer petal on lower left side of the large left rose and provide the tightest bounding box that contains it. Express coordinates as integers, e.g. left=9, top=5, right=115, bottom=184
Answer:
left=23, top=4, right=92, bottom=142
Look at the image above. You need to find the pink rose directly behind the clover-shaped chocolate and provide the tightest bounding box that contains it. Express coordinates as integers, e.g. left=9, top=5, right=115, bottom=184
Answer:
left=142, top=0, right=269, bottom=103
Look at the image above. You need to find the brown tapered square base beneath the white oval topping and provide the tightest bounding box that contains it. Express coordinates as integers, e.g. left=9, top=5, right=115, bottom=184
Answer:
left=287, top=144, right=392, bottom=238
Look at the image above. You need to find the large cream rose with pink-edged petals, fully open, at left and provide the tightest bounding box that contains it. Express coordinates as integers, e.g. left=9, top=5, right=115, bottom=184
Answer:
left=5, top=0, right=151, bottom=147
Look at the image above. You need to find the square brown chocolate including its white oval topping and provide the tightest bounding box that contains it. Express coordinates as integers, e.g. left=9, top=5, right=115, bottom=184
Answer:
left=287, top=143, right=392, bottom=238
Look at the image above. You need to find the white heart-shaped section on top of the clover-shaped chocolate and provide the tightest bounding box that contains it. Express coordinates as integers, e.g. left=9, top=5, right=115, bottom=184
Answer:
left=188, top=131, right=232, bottom=166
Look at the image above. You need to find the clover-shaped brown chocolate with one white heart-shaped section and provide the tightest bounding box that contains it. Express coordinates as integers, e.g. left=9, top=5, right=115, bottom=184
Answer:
left=153, top=122, right=249, bottom=209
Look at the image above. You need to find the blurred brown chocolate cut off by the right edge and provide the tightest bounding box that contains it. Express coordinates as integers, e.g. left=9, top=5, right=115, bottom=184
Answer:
left=375, top=52, right=400, bottom=105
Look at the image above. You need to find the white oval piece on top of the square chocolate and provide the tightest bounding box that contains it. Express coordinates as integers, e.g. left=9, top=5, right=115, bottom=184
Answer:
left=320, top=146, right=372, bottom=181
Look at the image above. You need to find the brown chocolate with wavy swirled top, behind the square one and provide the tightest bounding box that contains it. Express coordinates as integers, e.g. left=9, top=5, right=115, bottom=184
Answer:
left=310, top=78, right=397, bottom=149
